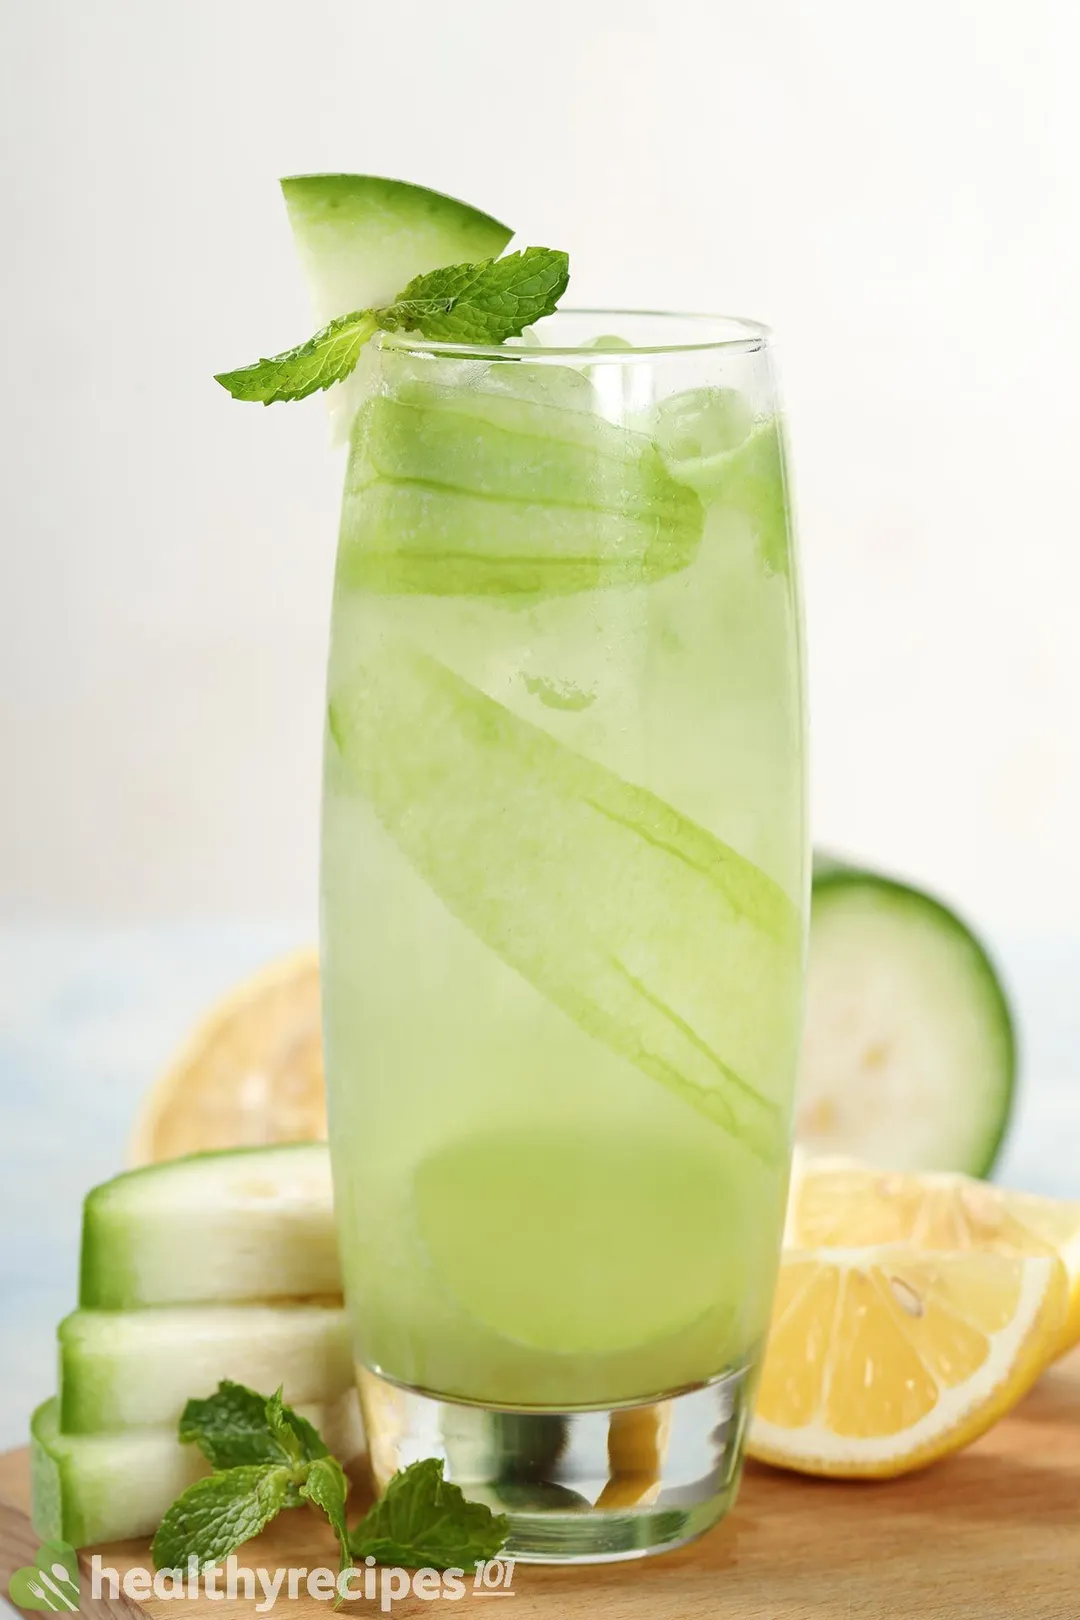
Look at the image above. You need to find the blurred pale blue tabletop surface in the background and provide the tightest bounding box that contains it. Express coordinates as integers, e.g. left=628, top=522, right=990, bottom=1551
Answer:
left=0, top=925, right=1080, bottom=1448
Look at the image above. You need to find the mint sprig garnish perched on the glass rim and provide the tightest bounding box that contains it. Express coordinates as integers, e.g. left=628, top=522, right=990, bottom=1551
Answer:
left=208, top=248, right=570, bottom=405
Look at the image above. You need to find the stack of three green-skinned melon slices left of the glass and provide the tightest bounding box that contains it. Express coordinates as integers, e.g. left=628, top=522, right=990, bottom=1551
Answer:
left=32, top=1144, right=352, bottom=1545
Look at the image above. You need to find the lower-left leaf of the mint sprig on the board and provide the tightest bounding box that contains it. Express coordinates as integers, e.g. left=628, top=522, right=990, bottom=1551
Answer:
left=151, top=1463, right=291, bottom=1570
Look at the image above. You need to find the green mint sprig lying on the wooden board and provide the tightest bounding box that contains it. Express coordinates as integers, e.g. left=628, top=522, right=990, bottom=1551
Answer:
left=151, top=1379, right=510, bottom=1570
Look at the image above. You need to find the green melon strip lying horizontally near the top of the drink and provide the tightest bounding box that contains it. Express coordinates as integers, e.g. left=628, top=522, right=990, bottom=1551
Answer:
left=338, top=382, right=704, bottom=598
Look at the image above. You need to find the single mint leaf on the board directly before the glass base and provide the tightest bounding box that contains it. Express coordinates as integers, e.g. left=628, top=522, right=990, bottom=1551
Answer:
left=348, top=1456, right=510, bottom=1570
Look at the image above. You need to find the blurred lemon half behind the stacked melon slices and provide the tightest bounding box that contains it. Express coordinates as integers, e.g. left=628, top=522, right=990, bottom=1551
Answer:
left=131, top=951, right=325, bottom=1165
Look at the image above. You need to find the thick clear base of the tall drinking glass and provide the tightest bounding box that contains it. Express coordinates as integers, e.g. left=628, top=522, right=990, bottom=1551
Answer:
left=358, top=1367, right=750, bottom=1563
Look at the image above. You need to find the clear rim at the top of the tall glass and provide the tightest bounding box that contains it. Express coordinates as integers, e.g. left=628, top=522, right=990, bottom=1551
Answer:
left=379, top=305, right=772, bottom=365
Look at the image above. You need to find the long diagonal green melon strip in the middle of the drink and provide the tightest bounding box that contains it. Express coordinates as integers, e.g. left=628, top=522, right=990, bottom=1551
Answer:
left=329, top=642, right=801, bottom=1163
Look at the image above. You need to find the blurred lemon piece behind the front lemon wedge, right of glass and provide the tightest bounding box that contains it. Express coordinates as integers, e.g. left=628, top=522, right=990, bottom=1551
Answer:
left=784, top=1153, right=1080, bottom=1354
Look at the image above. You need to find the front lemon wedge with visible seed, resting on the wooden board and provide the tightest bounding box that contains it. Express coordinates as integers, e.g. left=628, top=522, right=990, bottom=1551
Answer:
left=750, top=1246, right=1069, bottom=1479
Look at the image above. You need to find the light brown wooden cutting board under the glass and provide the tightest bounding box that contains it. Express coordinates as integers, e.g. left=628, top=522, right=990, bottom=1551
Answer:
left=0, top=1351, right=1080, bottom=1620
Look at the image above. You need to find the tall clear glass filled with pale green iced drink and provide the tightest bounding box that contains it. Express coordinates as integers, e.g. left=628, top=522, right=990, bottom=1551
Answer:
left=322, top=311, right=806, bottom=1560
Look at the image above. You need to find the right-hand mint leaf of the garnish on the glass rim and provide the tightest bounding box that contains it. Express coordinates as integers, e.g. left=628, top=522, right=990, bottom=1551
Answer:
left=376, top=248, right=570, bottom=343
